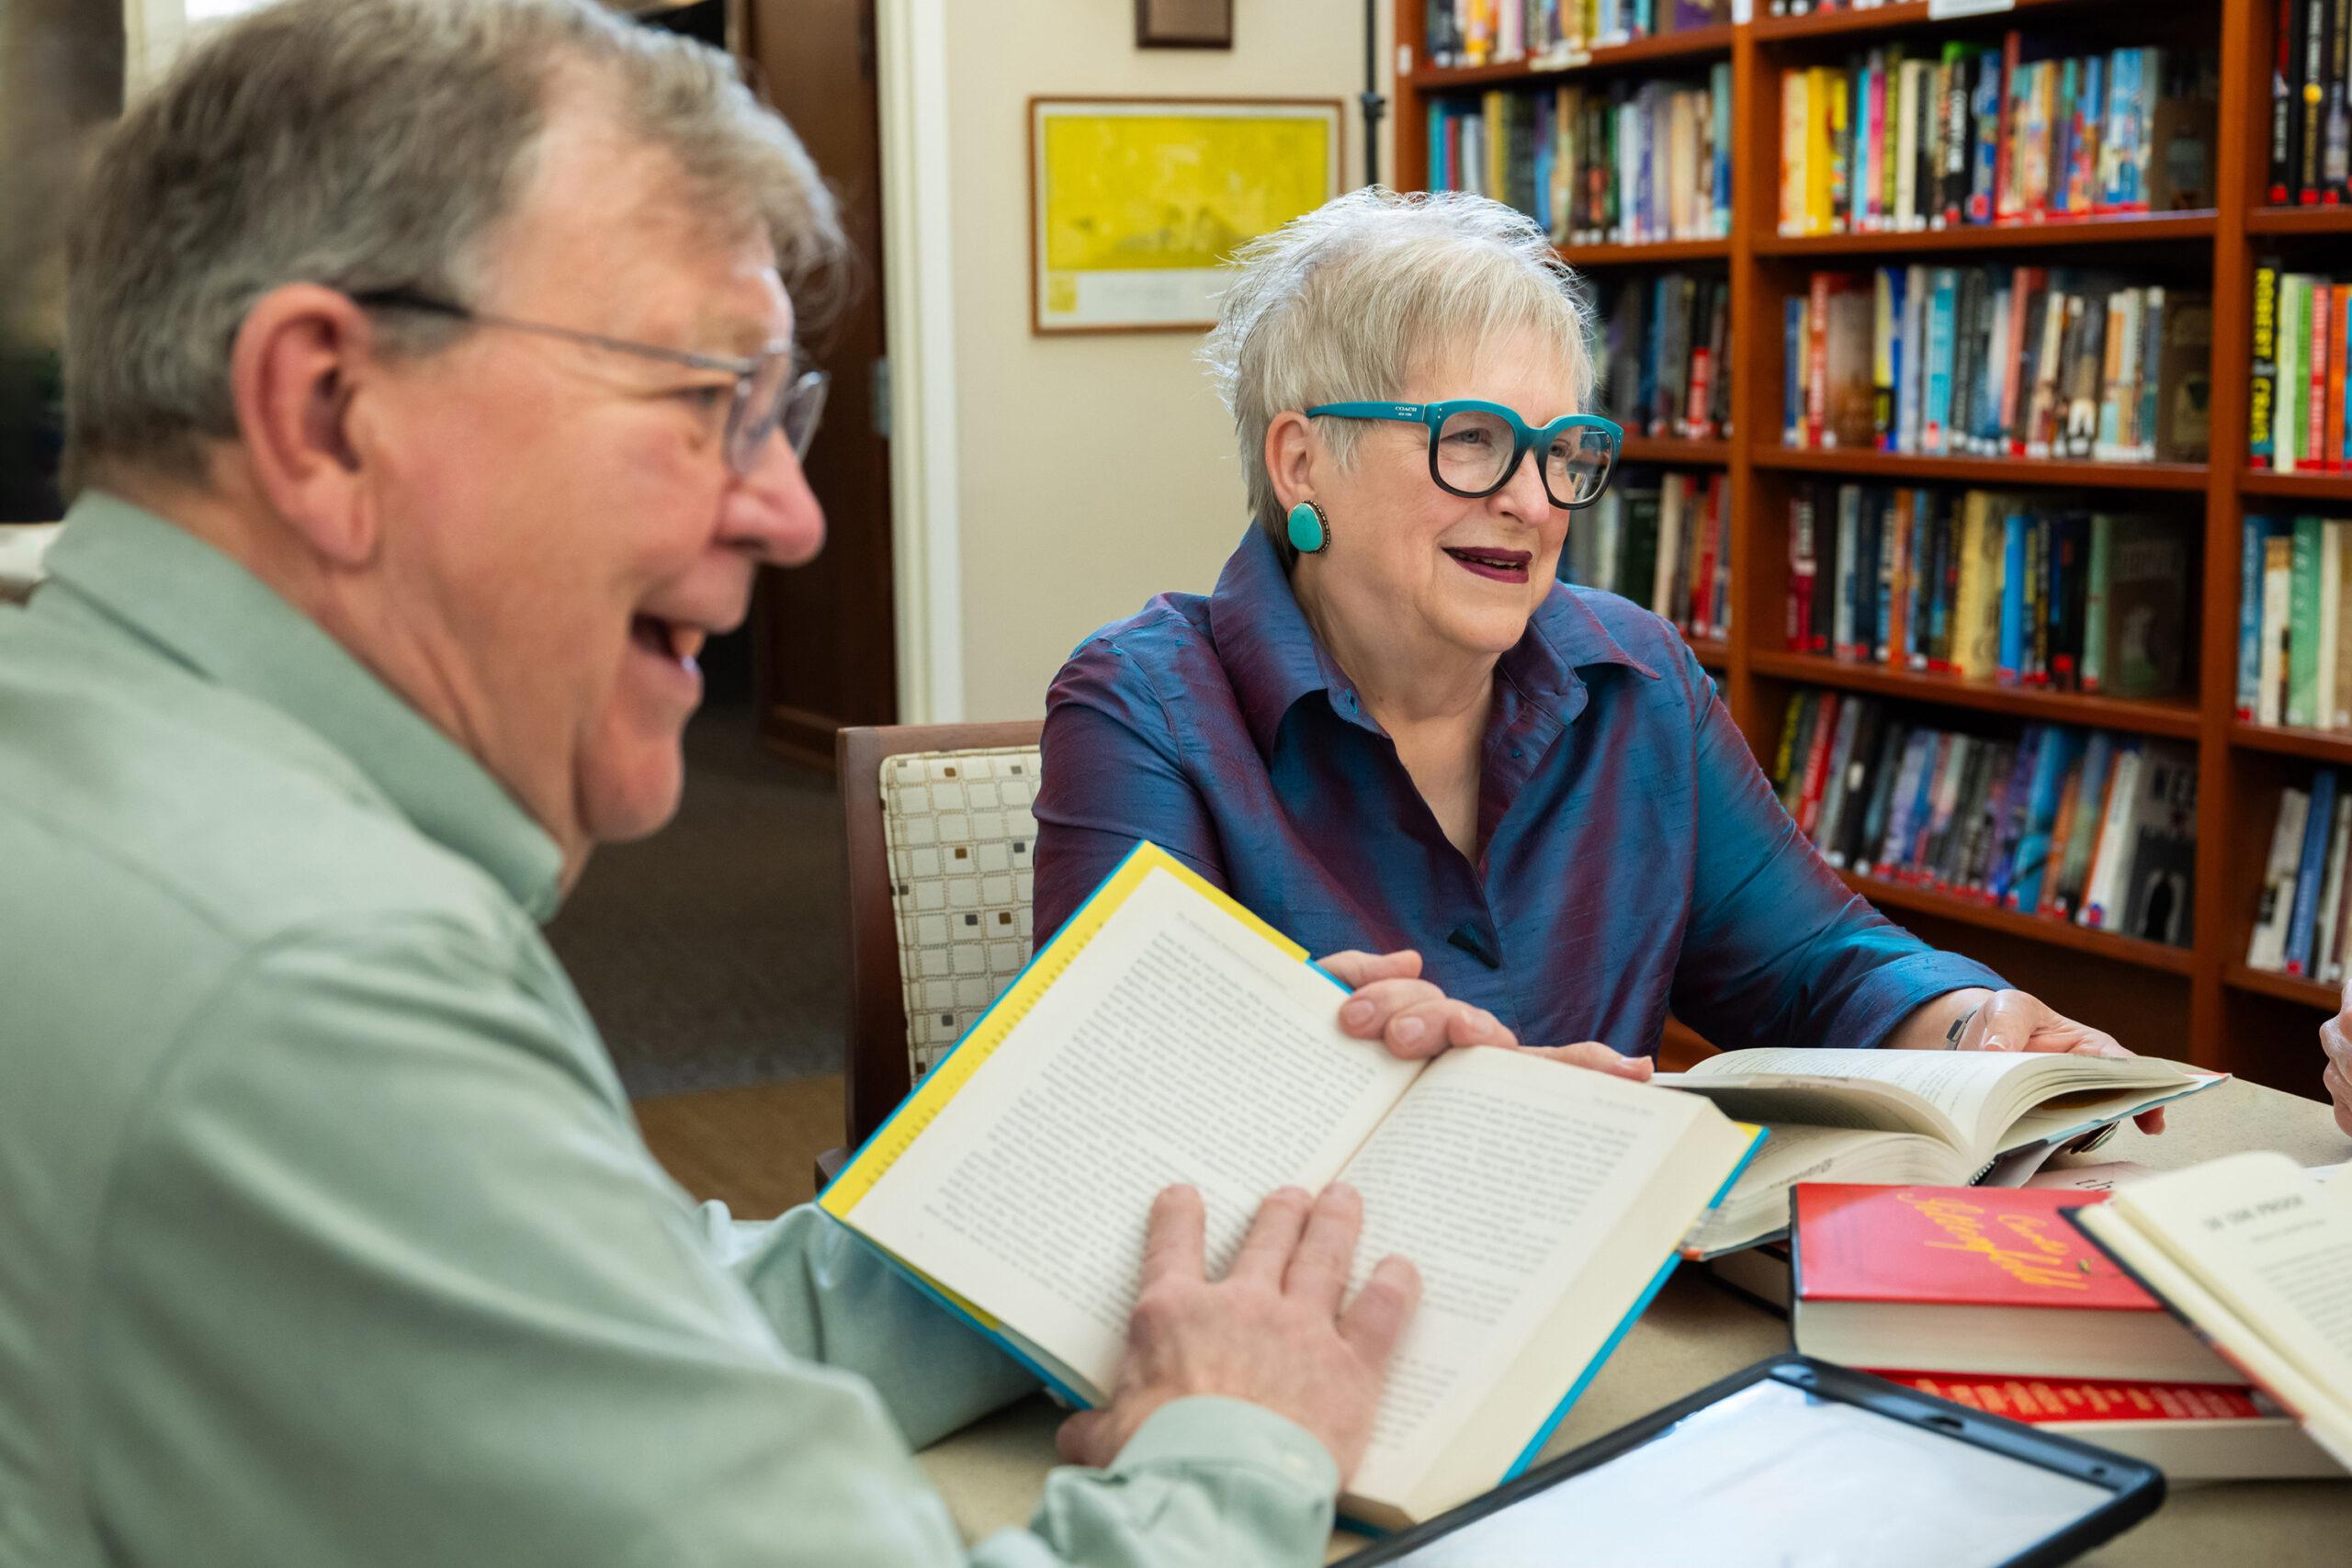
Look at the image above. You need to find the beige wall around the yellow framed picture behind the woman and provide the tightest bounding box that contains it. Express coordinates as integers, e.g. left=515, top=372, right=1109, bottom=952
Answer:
left=926, top=0, right=1393, bottom=719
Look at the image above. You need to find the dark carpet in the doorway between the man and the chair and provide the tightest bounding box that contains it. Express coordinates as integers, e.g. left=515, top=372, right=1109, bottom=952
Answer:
left=548, top=705, right=849, bottom=1098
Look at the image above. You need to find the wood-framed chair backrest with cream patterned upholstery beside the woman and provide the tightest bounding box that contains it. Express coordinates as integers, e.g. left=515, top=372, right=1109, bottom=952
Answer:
left=835, top=719, right=1045, bottom=1149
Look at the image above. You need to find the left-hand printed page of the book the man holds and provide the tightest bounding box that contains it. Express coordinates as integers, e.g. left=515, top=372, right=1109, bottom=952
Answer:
left=854, top=872, right=1420, bottom=1389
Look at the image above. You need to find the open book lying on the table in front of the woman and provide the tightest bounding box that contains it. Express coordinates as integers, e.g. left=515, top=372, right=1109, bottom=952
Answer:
left=1651, top=1048, right=2222, bottom=1258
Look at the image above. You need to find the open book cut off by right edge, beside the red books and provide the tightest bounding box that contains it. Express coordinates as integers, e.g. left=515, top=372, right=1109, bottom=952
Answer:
left=2067, top=1152, right=2352, bottom=1470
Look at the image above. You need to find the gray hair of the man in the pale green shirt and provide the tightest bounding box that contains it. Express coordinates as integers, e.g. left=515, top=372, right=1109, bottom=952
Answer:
left=66, top=0, right=847, bottom=489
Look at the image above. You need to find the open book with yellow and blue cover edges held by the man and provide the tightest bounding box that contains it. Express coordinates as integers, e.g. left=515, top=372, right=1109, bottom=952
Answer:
left=819, top=844, right=1759, bottom=1526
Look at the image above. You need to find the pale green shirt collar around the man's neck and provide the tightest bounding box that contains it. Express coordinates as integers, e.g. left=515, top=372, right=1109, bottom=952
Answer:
left=42, top=491, right=562, bottom=921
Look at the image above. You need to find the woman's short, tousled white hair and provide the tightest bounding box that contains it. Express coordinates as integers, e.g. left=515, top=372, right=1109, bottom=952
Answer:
left=1200, top=186, right=1592, bottom=557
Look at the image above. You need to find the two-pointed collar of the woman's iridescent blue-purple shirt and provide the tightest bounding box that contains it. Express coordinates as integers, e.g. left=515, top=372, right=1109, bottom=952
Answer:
left=1209, top=525, right=1658, bottom=755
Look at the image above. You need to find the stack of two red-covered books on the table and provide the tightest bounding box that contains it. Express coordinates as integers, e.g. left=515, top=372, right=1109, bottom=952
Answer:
left=1790, top=1182, right=2340, bottom=1481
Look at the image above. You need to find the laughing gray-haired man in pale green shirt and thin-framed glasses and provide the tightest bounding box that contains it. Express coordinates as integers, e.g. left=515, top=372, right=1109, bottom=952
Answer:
left=0, top=0, right=1484, bottom=1568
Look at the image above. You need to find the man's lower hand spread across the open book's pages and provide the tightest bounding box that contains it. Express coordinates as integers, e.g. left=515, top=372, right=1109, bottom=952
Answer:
left=1058, top=1182, right=1420, bottom=1483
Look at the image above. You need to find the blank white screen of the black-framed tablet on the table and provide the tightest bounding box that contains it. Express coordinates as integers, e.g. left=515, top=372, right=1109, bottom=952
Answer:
left=1395, top=1378, right=2112, bottom=1568
